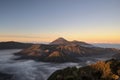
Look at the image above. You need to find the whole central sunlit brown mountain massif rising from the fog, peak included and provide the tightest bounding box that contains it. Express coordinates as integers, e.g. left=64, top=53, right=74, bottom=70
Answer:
left=15, top=38, right=120, bottom=62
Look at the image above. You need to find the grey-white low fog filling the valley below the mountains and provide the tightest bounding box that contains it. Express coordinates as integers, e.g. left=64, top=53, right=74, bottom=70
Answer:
left=0, top=49, right=113, bottom=80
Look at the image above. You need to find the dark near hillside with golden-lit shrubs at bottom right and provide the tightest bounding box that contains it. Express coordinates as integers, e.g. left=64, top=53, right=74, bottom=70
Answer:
left=48, top=59, right=120, bottom=80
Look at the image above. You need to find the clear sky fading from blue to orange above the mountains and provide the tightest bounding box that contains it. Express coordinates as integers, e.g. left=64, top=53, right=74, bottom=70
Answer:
left=0, top=0, right=120, bottom=43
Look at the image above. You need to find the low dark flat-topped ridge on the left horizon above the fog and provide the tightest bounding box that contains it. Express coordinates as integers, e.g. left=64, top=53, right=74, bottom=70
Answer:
left=0, top=41, right=33, bottom=49
